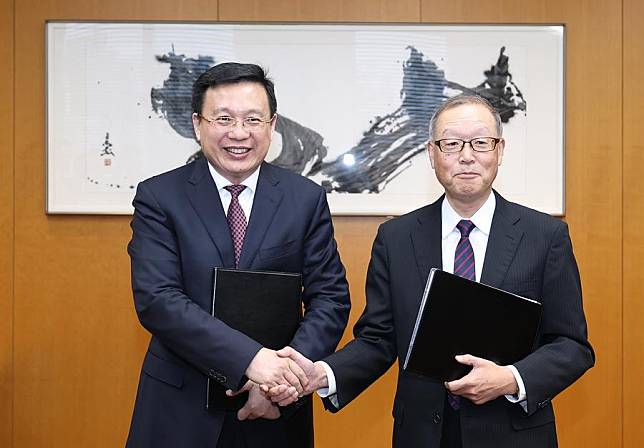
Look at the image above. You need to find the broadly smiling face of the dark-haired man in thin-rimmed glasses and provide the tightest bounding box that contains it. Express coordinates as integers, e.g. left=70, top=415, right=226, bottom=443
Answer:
left=192, top=82, right=275, bottom=184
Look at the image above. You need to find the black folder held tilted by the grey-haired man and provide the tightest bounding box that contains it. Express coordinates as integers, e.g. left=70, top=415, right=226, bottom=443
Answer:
left=403, top=268, right=541, bottom=381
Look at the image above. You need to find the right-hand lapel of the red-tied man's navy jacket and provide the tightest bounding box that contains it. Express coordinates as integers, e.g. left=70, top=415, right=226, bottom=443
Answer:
left=239, top=163, right=284, bottom=269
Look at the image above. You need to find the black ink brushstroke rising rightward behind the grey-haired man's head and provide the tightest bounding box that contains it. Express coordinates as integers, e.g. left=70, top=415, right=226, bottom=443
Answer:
left=309, top=46, right=526, bottom=193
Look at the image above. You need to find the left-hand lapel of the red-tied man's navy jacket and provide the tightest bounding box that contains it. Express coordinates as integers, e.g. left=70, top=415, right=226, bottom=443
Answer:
left=186, top=156, right=235, bottom=267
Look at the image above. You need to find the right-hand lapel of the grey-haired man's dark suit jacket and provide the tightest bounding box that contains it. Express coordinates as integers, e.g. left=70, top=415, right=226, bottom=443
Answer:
left=481, top=191, right=523, bottom=288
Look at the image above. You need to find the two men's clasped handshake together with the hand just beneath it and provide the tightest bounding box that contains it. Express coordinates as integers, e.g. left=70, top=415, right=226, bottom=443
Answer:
left=227, top=347, right=328, bottom=420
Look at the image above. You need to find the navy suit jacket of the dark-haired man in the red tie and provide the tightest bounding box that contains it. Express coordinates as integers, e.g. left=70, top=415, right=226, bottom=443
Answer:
left=128, top=157, right=350, bottom=448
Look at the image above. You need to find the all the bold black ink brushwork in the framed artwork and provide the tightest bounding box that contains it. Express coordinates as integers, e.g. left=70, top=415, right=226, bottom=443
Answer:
left=151, top=46, right=527, bottom=193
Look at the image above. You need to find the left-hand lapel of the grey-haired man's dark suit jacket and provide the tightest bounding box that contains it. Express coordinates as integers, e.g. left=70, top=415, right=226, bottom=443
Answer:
left=411, top=196, right=443, bottom=285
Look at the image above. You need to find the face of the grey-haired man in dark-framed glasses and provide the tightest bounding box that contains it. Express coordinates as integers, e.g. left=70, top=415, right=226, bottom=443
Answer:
left=429, top=104, right=505, bottom=211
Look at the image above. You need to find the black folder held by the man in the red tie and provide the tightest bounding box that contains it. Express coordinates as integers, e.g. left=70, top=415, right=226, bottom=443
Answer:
left=206, top=268, right=302, bottom=410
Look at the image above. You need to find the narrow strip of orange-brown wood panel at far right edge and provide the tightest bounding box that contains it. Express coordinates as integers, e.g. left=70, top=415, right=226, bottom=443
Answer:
left=623, top=0, right=644, bottom=447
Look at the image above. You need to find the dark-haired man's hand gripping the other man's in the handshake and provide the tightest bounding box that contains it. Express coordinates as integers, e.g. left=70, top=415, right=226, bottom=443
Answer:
left=246, top=348, right=309, bottom=394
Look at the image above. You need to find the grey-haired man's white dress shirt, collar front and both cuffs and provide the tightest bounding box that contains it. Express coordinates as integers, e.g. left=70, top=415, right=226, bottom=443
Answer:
left=318, top=193, right=527, bottom=412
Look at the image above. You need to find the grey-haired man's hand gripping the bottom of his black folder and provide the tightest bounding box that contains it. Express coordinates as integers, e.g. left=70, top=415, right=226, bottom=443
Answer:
left=445, top=355, right=519, bottom=404
